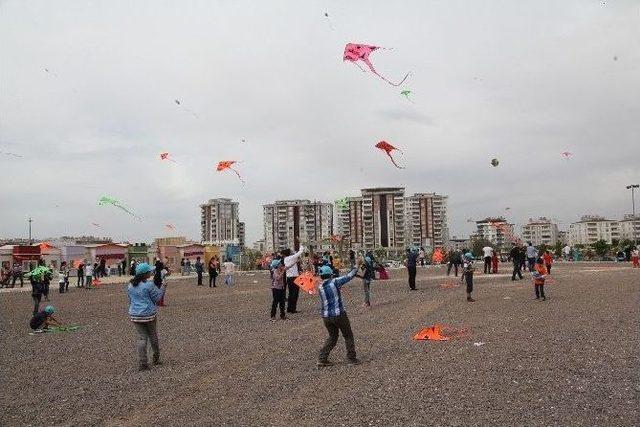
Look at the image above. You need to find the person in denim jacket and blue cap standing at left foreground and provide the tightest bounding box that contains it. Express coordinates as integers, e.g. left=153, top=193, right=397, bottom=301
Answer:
left=127, top=262, right=167, bottom=371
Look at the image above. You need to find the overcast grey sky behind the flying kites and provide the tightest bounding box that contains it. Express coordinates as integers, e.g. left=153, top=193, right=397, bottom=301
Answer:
left=0, top=0, right=640, bottom=243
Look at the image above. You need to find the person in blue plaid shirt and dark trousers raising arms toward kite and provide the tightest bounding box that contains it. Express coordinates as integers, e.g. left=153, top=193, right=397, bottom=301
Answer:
left=318, top=265, right=360, bottom=368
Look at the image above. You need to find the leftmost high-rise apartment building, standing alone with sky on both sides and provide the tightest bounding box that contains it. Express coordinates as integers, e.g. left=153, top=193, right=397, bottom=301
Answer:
left=200, top=198, right=244, bottom=244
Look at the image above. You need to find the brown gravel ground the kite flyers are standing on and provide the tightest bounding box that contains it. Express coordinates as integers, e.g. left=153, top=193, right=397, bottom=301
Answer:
left=0, top=263, right=640, bottom=426
